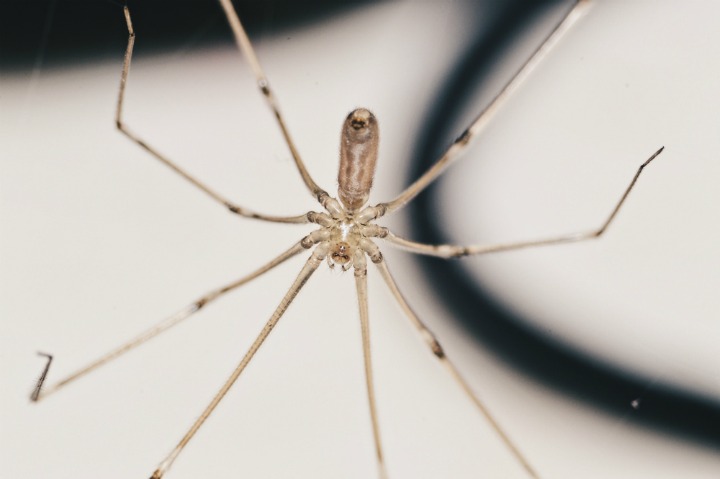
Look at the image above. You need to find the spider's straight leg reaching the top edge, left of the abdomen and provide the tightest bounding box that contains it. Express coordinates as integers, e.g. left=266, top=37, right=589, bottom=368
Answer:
left=220, top=0, right=328, bottom=201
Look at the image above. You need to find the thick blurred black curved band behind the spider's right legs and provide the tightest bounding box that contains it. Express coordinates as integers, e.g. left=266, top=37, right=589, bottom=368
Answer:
left=409, top=0, right=720, bottom=450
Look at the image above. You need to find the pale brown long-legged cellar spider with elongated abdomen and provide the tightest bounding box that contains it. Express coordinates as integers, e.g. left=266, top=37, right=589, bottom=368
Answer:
left=31, top=0, right=663, bottom=479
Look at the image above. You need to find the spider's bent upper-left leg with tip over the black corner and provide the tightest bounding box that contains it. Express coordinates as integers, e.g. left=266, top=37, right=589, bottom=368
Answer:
left=115, top=7, right=308, bottom=223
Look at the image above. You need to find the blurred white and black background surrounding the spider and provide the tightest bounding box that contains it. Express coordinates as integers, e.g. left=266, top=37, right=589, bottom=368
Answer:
left=0, top=0, right=720, bottom=479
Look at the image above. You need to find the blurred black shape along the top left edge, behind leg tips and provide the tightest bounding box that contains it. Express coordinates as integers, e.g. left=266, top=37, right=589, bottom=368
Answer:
left=0, top=0, right=370, bottom=70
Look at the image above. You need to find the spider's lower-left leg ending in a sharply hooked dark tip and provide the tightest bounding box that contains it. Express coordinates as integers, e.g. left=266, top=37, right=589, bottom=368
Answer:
left=30, top=243, right=305, bottom=401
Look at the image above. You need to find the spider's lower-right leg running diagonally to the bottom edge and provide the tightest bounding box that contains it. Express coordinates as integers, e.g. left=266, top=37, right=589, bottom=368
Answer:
left=376, top=260, right=539, bottom=478
